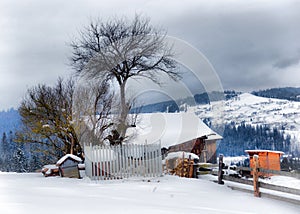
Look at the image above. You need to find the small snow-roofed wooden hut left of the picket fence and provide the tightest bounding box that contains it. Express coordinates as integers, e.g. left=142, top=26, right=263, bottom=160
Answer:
left=56, top=154, right=82, bottom=178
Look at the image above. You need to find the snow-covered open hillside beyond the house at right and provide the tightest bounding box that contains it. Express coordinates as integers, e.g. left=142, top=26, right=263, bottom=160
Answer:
left=188, top=93, right=300, bottom=147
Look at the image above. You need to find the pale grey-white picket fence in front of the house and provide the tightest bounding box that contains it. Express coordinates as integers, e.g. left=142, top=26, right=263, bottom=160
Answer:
left=84, top=143, right=162, bottom=180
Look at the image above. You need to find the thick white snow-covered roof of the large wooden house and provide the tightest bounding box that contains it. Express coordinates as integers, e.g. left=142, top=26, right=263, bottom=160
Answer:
left=126, top=112, right=222, bottom=148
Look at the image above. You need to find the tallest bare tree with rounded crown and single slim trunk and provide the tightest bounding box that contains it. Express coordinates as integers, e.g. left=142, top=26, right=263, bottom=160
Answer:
left=70, top=15, right=180, bottom=137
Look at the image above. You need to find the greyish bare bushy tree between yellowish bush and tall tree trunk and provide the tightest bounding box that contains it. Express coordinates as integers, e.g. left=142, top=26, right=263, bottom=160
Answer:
left=73, top=78, right=114, bottom=144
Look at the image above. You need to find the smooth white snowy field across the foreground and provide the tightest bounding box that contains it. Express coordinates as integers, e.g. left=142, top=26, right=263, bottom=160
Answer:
left=0, top=172, right=300, bottom=214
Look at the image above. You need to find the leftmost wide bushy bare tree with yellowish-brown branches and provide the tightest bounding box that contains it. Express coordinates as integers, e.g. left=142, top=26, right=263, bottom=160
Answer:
left=16, top=79, right=82, bottom=157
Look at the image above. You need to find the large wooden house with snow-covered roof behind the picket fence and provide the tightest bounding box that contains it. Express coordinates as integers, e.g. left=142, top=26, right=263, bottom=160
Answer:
left=126, top=112, right=222, bottom=163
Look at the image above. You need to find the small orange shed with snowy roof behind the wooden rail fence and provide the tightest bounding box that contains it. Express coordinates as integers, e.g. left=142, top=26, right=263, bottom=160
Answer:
left=245, top=150, right=284, bottom=176
